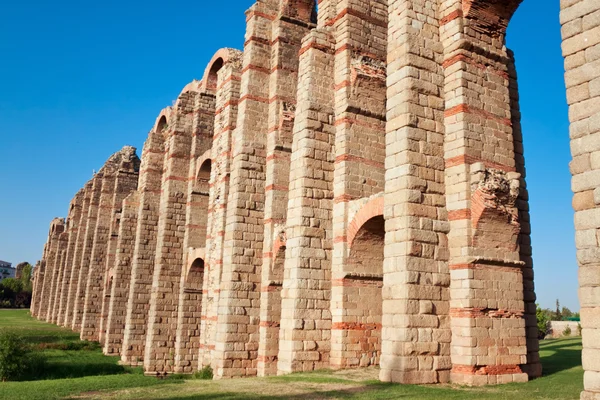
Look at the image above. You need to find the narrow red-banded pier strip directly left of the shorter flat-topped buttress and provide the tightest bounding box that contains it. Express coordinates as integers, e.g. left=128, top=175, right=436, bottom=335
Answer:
left=258, top=0, right=315, bottom=376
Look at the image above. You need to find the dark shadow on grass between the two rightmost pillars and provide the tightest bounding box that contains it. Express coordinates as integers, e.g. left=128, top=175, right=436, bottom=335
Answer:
left=540, top=339, right=581, bottom=376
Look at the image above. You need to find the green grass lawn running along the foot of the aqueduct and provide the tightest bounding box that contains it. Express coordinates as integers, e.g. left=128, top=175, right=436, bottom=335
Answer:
left=0, top=310, right=583, bottom=400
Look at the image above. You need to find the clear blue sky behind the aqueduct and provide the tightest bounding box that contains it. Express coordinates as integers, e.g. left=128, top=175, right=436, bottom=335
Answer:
left=0, top=0, right=579, bottom=309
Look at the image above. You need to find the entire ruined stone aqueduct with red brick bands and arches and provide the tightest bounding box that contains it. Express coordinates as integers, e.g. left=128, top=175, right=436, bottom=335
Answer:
left=32, top=0, right=600, bottom=399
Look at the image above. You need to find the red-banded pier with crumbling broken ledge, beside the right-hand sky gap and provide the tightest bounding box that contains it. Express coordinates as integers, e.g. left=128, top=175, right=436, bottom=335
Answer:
left=440, top=0, right=535, bottom=385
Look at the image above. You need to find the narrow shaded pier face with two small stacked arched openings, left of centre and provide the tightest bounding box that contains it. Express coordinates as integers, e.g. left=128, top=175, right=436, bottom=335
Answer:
left=174, top=89, right=215, bottom=373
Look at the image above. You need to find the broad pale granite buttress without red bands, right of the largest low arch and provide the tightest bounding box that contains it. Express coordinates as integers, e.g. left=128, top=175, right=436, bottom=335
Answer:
left=380, top=0, right=451, bottom=384
